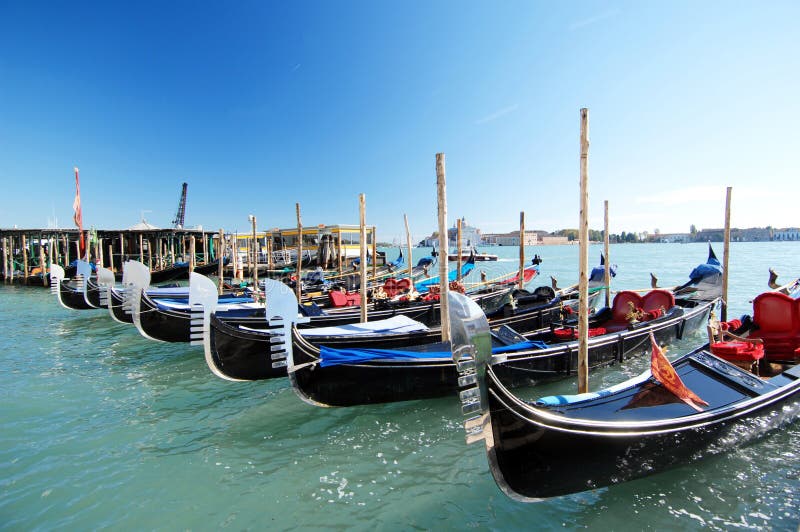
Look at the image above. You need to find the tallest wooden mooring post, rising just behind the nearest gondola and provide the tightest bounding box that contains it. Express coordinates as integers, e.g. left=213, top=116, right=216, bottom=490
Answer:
left=578, top=108, right=589, bottom=393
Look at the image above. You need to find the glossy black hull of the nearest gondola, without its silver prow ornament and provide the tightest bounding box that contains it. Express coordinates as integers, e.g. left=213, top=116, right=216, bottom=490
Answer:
left=486, top=350, right=800, bottom=501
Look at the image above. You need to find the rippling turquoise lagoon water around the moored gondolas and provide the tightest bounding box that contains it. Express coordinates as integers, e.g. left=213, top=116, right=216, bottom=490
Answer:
left=0, top=243, right=800, bottom=530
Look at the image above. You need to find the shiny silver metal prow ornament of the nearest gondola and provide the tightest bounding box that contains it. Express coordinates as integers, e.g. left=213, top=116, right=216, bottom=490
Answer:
left=447, top=292, right=492, bottom=445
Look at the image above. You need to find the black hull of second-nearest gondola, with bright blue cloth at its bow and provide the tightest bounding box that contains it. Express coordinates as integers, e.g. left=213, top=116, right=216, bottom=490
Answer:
left=289, top=302, right=715, bottom=406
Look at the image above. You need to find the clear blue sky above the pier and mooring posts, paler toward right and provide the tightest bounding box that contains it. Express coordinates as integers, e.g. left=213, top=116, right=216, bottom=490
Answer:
left=0, top=1, right=800, bottom=241
